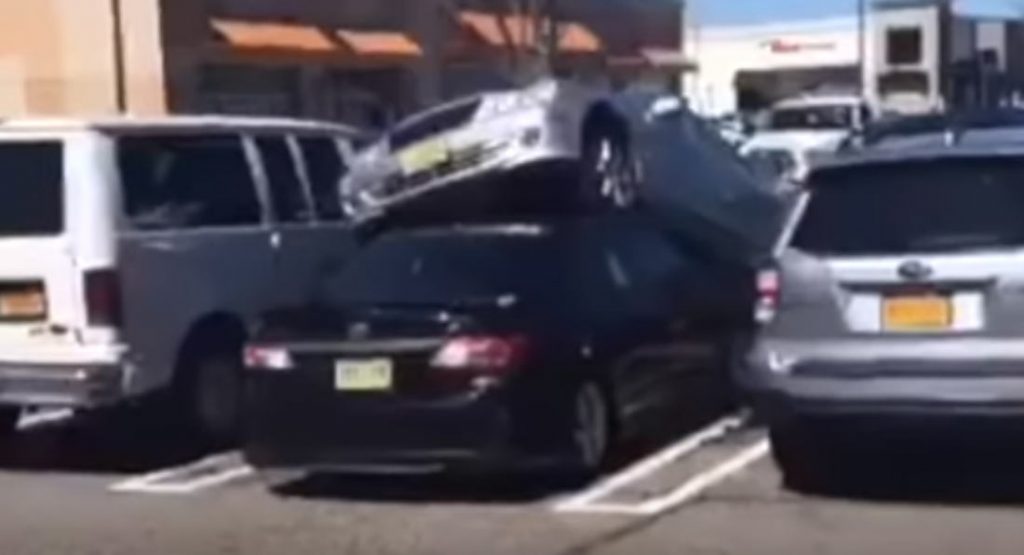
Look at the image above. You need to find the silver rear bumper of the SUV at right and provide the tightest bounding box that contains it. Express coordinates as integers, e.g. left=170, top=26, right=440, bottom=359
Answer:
left=735, top=339, right=1024, bottom=418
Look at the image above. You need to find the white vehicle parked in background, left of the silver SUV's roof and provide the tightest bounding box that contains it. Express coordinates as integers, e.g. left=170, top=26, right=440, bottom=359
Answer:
left=740, top=95, right=871, bottom=181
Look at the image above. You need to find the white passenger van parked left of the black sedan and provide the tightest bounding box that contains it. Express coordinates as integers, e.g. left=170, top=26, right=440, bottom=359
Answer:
left=0, top=117, right=356, bottom=438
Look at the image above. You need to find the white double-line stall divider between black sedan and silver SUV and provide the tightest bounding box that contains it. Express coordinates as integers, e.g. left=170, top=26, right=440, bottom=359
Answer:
left=550, top=414, right=770, bottom=516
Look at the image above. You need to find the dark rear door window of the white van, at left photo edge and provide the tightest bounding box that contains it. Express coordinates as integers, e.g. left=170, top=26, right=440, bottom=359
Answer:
left=0, top=141, right=63, bottom=237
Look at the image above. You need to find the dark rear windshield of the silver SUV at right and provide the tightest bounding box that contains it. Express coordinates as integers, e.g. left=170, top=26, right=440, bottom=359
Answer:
left=794, top=158, right=1024, bottom=256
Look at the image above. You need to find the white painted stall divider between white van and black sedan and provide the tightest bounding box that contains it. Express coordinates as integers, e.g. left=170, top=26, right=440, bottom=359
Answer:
left=109, top=453, right=255, bottom=495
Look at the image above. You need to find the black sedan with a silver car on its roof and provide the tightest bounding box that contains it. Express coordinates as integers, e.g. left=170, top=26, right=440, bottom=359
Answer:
left=239, top=213, right=753, bottom=485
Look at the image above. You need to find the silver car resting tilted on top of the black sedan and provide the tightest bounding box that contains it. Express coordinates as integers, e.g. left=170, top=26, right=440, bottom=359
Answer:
left=343, top=81, right=781, bottom=270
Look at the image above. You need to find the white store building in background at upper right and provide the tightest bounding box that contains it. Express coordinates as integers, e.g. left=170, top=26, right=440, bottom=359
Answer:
left=683, top=0, right=1024, bottom=115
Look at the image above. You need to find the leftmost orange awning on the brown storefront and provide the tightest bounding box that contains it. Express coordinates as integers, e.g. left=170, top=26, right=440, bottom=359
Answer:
left=211, top=19, right=339, bottom=53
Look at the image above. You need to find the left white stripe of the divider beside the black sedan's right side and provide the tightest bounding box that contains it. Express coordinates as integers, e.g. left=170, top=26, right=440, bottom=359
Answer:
left=554, top=415, right=748, bottom=512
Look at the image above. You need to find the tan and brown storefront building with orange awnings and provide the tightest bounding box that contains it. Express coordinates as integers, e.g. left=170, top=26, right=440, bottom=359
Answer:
left=0, top=0, right=681, bottom=127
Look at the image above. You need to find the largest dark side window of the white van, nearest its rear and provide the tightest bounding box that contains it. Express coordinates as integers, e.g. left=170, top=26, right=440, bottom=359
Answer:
left=118, top=135, right=261, bottom=229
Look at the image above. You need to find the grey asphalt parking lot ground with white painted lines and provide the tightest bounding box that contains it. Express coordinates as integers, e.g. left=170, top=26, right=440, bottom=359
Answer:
left=6, top=401, right=1024, bottom=555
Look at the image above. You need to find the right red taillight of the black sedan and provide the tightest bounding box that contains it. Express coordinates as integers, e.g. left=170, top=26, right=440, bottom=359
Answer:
left=431, top=336, right=529, bottom=374
